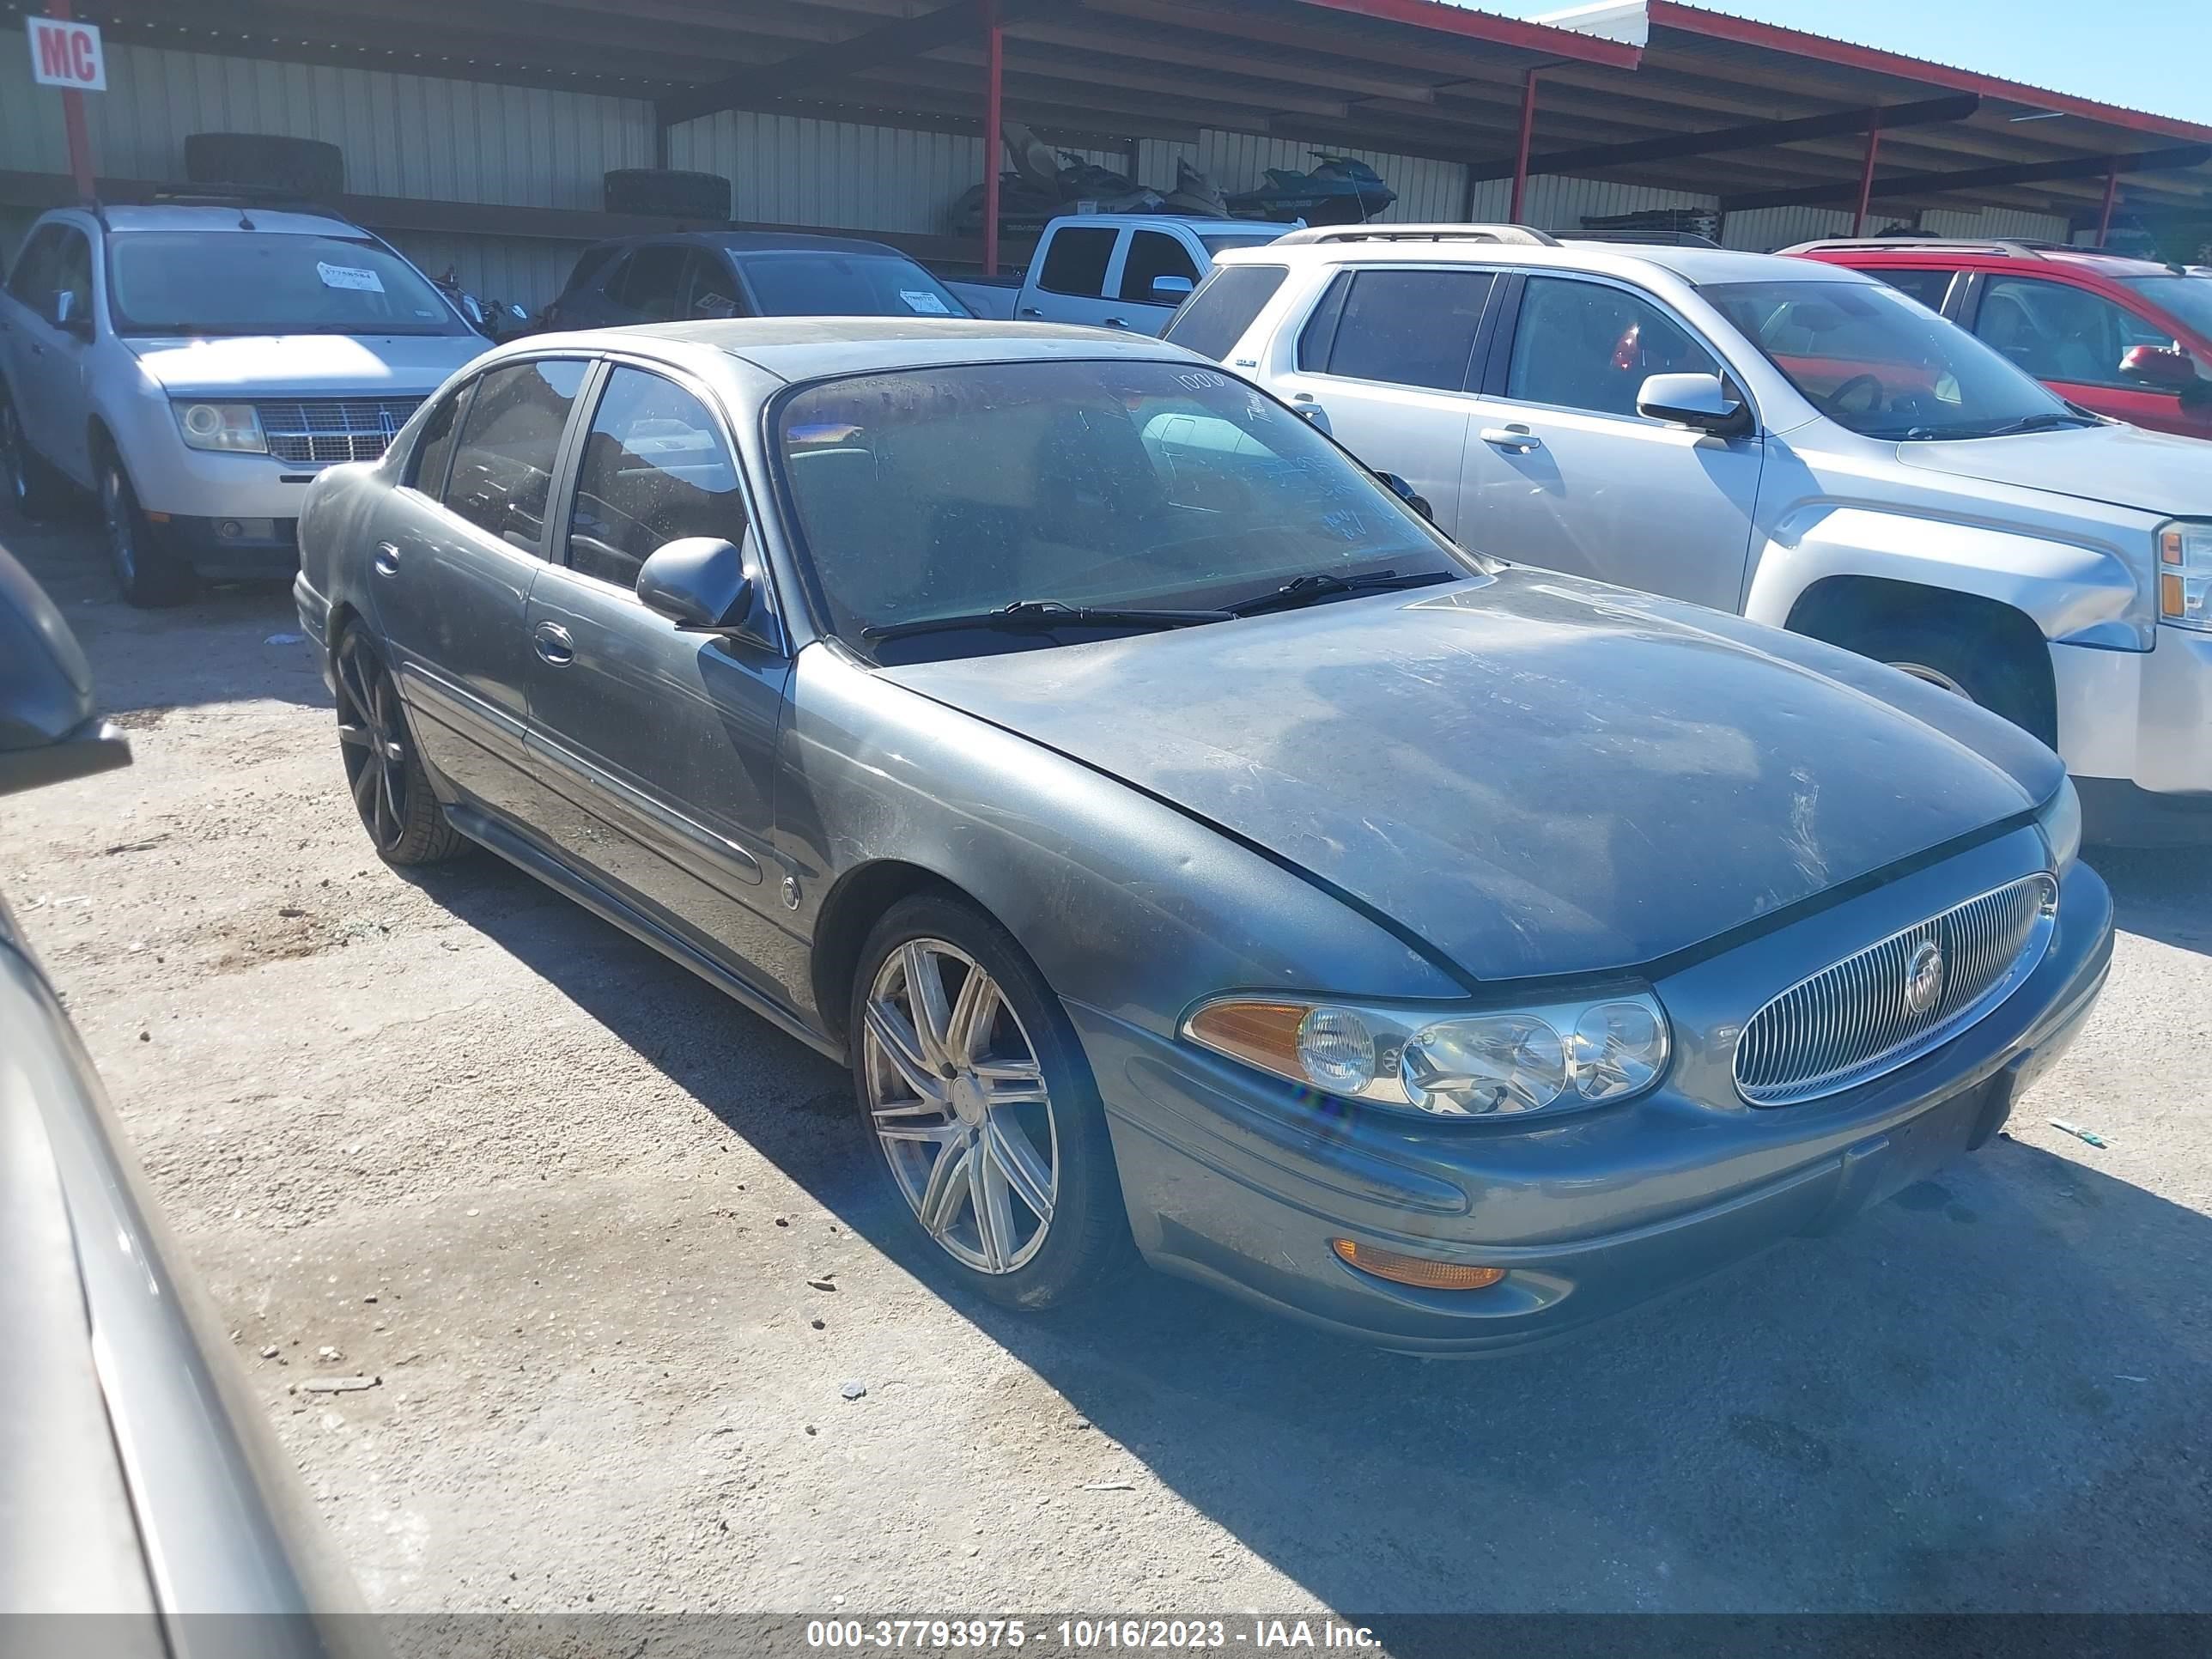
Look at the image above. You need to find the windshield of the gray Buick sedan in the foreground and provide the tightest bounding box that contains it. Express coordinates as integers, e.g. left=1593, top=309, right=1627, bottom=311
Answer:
left=779, top=361, right=1480, bottom=654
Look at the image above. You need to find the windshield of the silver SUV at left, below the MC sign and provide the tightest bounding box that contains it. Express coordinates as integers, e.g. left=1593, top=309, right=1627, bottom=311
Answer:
left=108, top=230, right=469, bottom=334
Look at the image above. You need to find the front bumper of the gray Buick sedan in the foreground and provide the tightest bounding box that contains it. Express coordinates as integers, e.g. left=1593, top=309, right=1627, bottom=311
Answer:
left=1071, top=849, right=2112, bottom=1354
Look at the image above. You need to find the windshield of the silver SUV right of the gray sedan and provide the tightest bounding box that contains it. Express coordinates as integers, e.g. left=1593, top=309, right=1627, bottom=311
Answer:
left=1698, top=281, right=2086, bottom=438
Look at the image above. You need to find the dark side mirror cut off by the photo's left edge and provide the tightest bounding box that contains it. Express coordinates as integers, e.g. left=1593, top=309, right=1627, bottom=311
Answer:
left=0, top=550, right=131, bottom=794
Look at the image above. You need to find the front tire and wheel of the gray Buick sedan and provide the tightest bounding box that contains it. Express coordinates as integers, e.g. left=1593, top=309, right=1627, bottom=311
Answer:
left=849, top=894, right=1133, bottom=1310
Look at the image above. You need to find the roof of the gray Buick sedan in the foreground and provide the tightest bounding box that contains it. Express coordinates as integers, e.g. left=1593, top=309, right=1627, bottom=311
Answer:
left=515, top=316, right=1203, bottom=380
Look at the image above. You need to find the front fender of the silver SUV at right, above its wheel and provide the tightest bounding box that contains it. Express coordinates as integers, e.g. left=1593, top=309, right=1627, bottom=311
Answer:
left=1743, top=507, right=2152, bottom=650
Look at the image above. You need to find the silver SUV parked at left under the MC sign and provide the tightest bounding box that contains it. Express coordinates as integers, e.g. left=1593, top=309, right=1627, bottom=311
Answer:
left=0, top=199, right=487, bottom=604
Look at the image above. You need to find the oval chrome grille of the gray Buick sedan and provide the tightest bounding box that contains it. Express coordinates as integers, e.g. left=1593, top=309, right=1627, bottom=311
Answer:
left=1736, top=876, right=2059, bottom=1106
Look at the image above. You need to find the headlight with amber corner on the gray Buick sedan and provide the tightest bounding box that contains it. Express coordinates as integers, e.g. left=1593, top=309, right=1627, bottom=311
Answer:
left=1183, top=991, right=1668, bottom=1117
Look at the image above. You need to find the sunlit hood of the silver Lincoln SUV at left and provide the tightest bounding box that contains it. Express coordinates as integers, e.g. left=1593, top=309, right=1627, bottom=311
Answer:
left=128, top=334, right=491, bottom=398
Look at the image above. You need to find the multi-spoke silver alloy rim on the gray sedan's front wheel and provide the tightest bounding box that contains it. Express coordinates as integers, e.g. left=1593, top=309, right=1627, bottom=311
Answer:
left=860, top=938, right=1060, bottom=1274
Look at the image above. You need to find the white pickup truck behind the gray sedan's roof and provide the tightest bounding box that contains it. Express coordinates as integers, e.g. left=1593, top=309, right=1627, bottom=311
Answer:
left=945, top=212, right=1291, bottom=334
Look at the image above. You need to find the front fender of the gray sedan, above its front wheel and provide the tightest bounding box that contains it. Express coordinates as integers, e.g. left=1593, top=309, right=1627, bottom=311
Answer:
left=776, top=644, right=1464, bottom=1033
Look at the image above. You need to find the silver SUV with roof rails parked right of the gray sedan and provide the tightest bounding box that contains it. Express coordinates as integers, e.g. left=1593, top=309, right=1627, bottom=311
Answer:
left=1168, top=226, right=2212, bottom=841
